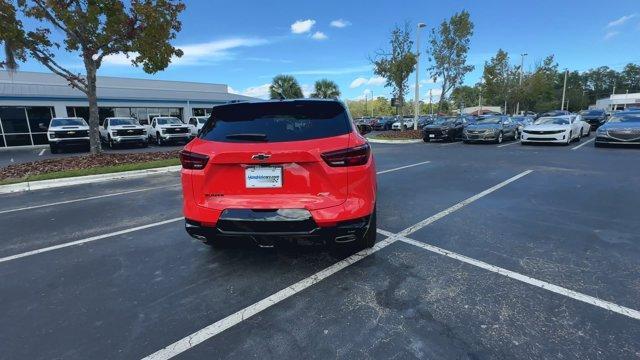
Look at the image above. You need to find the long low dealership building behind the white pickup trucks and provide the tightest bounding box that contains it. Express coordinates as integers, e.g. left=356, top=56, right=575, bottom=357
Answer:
left=0, top=71, right=255, bottom=148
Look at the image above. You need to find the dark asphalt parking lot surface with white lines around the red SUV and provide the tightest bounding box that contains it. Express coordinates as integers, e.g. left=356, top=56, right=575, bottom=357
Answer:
left=0, top=139, right=640, bottom=359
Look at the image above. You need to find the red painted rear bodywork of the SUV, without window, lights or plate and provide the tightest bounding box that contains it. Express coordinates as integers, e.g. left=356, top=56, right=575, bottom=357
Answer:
left=181, top=127, right=377, bottom=227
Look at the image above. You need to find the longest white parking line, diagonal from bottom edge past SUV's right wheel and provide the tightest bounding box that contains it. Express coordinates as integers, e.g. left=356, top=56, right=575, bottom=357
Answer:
left=143, top=170, right=531, bottom=360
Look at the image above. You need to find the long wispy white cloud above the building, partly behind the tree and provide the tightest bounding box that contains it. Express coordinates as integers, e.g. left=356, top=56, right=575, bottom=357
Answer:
left=102, top=37, right=269, bottom=66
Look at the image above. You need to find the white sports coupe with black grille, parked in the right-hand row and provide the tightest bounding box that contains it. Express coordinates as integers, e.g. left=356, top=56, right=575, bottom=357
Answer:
left=521, top=115, right=589, bottom=145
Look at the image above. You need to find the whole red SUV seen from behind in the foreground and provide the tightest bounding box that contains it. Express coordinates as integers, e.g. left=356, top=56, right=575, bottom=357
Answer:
left=180, top=100, right=376, bottom=248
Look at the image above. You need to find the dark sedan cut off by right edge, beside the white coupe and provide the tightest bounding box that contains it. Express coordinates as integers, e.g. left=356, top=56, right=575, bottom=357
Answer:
left=595, top=111, right=640, bottom=147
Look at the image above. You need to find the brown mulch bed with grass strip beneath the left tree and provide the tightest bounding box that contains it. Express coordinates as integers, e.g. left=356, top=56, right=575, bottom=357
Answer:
left=0, top=150, right=179, bottom=180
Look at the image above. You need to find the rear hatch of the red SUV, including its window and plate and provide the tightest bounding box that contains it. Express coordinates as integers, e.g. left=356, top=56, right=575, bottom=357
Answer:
left=188, top=100, right=352, bottom=210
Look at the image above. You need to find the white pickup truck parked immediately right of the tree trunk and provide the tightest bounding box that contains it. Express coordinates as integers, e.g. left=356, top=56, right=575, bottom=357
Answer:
left=99, top=117, right=149, bottom=149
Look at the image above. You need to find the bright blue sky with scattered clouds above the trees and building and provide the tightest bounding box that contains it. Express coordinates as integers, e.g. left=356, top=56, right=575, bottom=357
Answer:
left=13, top=0, right=640, bottom=100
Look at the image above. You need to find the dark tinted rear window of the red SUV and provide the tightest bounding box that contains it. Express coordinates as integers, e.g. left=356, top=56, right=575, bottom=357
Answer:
left=200, top=101, right=351, bottom=142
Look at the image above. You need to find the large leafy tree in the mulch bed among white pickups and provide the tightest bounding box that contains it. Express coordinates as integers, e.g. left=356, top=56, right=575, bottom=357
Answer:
left=0, top=0, right=185, bottom=154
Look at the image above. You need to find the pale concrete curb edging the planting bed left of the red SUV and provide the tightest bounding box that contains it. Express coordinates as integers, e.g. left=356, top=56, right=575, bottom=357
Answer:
left=0, top=165, right=182, bottom=194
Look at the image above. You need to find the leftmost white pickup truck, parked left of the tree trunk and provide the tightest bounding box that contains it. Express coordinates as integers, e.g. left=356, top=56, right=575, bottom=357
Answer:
left=47, top=117, right=89, bottom=154
